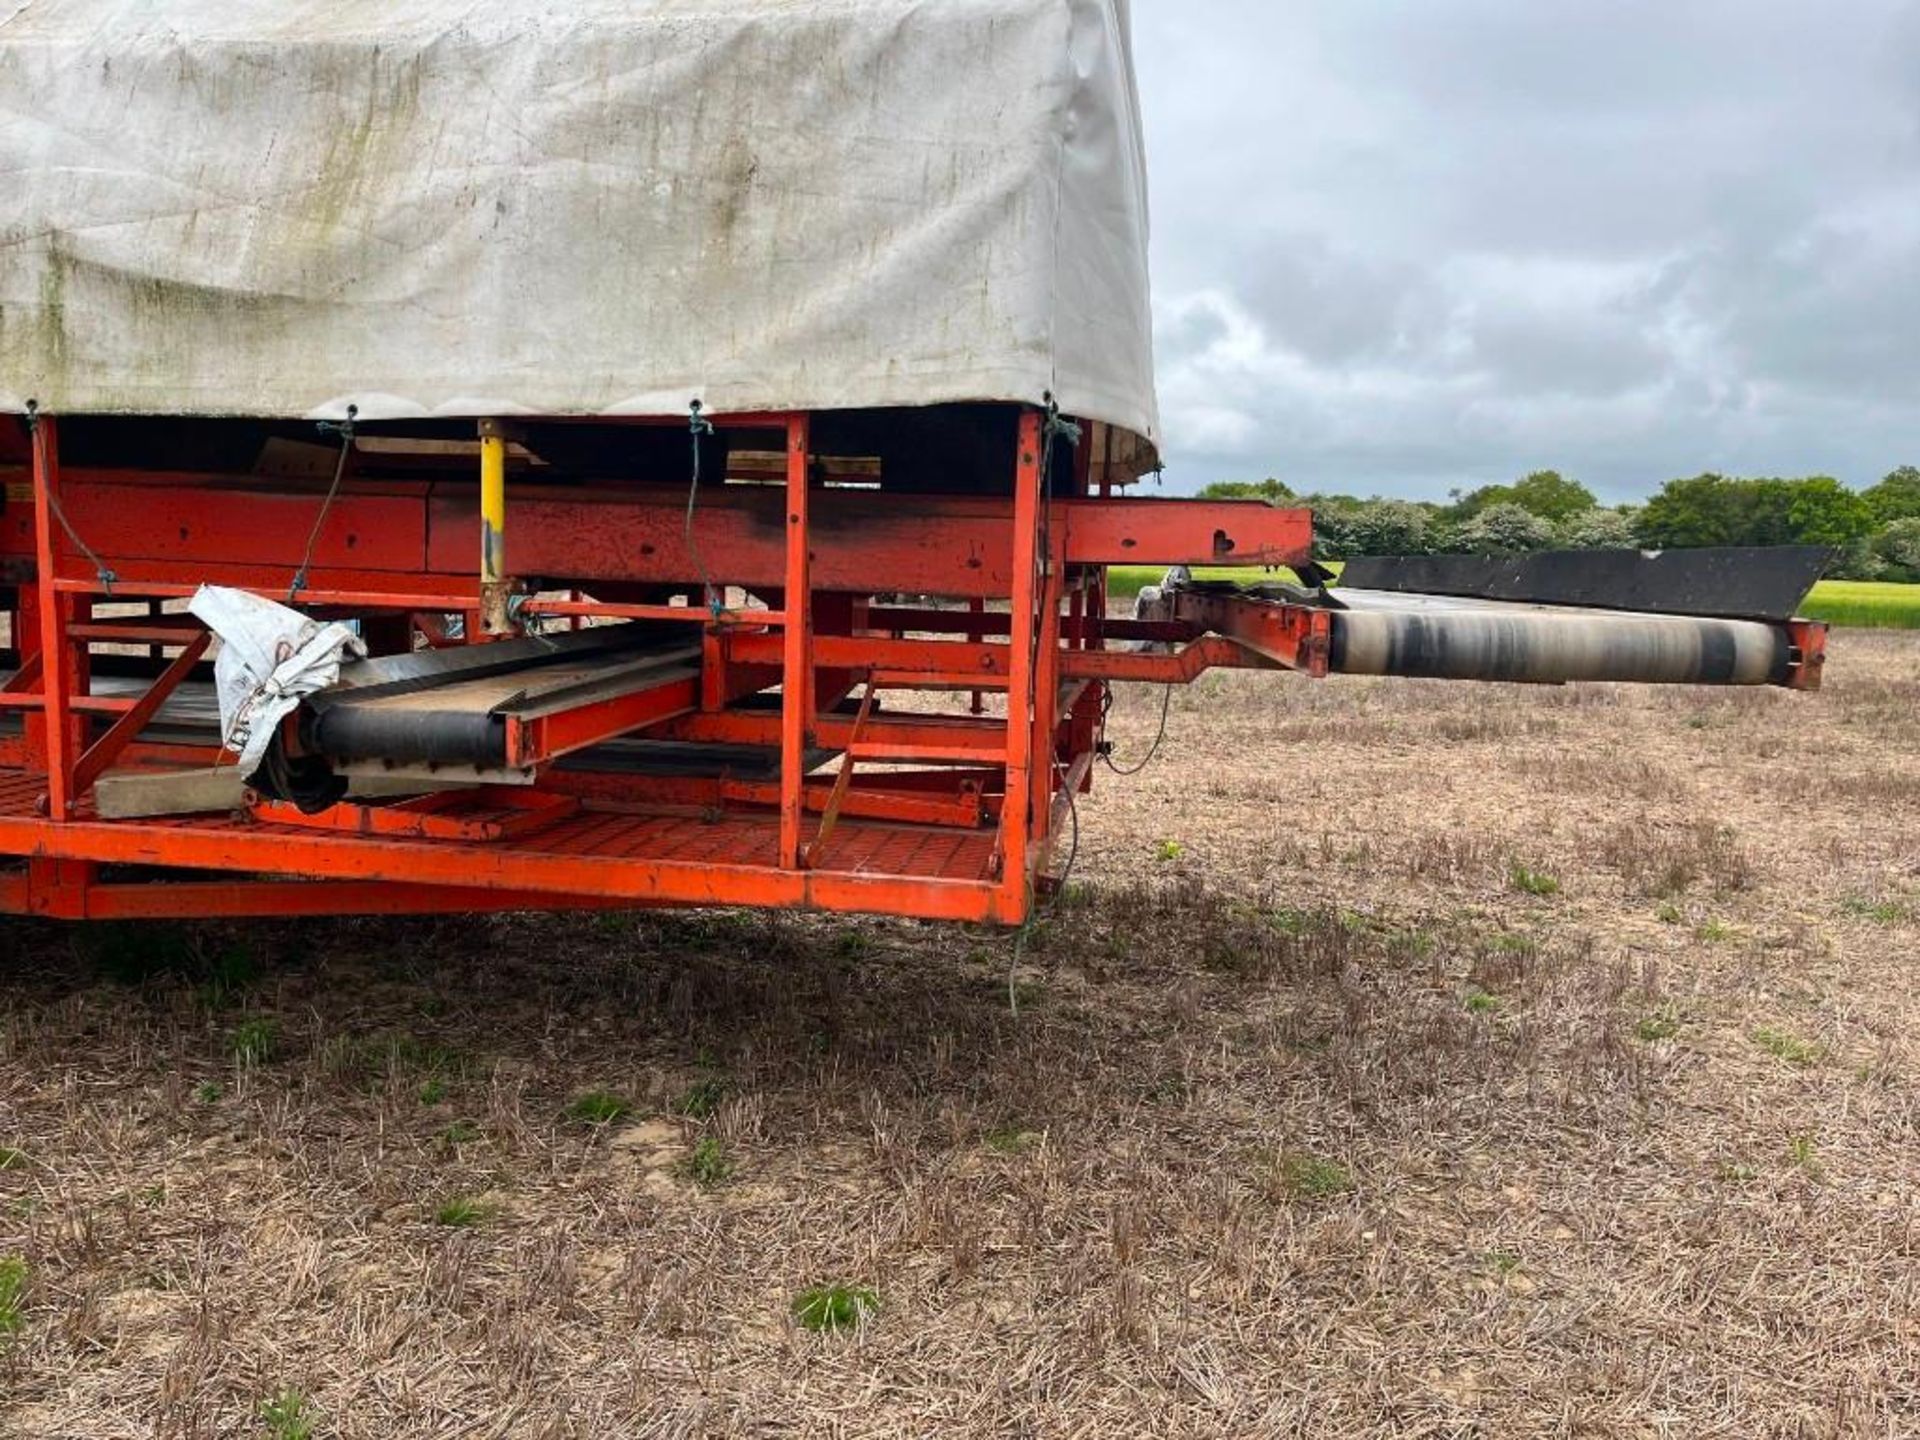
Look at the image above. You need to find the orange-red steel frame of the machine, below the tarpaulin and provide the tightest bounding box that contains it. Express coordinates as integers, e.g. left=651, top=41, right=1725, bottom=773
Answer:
left=0, top=411, right=1325, bottom=924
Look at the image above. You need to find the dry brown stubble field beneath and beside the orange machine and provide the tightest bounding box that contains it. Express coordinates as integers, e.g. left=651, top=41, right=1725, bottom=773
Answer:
left=0, top=634, right=1920, bottom=1440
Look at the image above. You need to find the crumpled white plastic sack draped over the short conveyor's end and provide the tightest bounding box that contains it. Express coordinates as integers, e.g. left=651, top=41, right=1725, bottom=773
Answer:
left=188, top=586, right=367, bottom=774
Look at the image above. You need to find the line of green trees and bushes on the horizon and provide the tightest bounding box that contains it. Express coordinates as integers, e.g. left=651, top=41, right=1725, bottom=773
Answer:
left=1200, top=465, right=1920, bottom=582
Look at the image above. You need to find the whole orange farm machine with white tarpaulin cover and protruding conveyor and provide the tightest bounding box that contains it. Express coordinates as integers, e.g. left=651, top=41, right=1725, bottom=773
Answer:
left=0, top=0, right=1824, bottom=924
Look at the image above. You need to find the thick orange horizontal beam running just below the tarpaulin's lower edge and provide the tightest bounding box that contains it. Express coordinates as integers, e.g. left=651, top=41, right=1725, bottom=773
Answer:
left=0, top=468, right=1311, bottom=609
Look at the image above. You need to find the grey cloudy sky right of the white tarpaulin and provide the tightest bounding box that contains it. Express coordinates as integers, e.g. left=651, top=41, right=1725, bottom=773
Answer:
left=1133, top=0, right=1920, bottom=499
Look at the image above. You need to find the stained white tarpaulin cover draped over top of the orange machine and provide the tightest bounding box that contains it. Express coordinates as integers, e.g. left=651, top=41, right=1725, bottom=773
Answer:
left=0, top=0, right=1158, bottom=438
